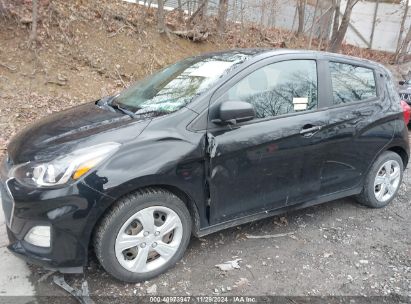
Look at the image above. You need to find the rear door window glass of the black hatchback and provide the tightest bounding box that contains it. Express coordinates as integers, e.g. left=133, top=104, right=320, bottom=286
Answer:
left=330, top=62, right=377, bottom=105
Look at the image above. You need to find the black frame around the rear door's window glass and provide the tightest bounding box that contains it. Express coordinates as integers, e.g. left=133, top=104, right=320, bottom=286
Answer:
left=326, top=58, right=381, bottom=109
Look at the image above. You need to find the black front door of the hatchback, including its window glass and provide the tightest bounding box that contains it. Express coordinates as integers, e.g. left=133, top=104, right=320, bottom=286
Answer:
left=207, top=59, right=328, bottom=224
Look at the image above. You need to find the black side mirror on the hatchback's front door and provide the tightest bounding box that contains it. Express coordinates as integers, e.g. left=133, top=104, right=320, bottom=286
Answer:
left=212, top=101, right=255, bottom=124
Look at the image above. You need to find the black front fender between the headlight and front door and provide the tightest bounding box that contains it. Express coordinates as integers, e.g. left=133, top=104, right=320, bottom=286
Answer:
left=84, top=131, right=207, bottom=233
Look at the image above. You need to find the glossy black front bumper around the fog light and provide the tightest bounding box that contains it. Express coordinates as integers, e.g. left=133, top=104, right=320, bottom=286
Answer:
left=0, top=163, right=113, bottom=272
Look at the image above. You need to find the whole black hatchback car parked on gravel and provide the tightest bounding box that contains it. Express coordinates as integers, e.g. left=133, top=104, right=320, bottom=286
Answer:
left=1, top=49, right=410, bottom=282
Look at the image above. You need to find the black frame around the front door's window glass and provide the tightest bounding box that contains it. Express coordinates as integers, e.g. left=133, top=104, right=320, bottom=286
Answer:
left=206, top=54, right=326, bottom=130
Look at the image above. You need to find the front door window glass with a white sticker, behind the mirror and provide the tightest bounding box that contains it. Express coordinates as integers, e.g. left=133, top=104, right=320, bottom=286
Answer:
left=222, top=60, right=317, bottom=118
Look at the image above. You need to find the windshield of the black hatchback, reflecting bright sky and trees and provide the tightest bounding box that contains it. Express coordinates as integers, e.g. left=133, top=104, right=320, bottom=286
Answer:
left=112, top=51, right=254, bottom=114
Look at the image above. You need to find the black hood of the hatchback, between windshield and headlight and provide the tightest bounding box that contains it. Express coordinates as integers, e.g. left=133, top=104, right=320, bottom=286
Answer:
left=7, top=102, right=150, bottom=164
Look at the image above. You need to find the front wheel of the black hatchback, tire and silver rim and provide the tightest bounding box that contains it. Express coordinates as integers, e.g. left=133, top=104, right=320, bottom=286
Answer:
left=94, top=188, right=191, bottom=283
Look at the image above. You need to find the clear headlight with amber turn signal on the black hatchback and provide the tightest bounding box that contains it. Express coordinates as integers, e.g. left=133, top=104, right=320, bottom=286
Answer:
left=9, top=142, right=120, bottom=187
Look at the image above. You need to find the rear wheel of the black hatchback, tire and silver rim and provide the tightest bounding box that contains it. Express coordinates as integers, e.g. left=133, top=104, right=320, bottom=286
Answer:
left=356, top=151, right=404, bottom=208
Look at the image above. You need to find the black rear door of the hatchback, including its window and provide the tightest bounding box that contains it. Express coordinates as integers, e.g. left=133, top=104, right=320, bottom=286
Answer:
left=321, top=60, right=395, bottom=194
